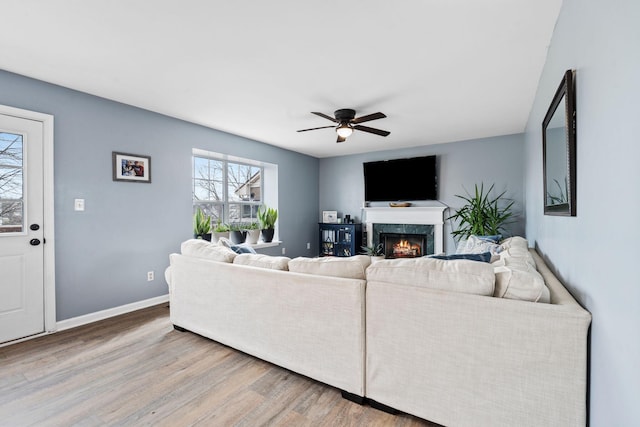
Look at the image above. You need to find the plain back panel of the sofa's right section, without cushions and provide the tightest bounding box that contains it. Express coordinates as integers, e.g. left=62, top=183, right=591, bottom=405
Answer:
left=366, top=281, right=591, bottom=426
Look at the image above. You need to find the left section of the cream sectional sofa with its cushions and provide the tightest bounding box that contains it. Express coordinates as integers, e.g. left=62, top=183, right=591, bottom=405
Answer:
left=166, top=244, right=369, bottom=400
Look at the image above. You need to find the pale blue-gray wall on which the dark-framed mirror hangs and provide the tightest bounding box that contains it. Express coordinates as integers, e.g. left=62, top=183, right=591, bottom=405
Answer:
left=526, top=0, right=640, bottom=426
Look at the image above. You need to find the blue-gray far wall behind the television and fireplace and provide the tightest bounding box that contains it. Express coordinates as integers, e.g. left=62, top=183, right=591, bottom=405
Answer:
left=318, top=134, right=524, bottom=252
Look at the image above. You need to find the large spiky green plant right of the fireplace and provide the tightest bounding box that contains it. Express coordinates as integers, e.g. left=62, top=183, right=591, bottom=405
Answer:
left=447, top=184, right=514, bottom=241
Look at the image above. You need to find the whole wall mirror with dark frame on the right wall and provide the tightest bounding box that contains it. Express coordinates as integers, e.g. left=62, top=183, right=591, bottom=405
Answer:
left=542, top=70, right=576, bottom=216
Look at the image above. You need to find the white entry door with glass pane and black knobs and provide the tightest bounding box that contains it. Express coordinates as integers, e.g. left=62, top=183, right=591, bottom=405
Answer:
left=0, top=114, right=45, bottom=343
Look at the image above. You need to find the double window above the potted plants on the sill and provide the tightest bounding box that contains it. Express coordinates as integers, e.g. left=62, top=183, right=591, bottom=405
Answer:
left=192, top=150, right=265, bottom=224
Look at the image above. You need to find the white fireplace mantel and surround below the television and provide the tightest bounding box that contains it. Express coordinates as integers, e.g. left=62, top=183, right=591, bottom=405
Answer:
left=363, top=206, right=447, bottom=254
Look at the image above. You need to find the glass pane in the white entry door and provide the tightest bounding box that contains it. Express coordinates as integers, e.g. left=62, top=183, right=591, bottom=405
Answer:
left=0, top=132, right=24, bottom=233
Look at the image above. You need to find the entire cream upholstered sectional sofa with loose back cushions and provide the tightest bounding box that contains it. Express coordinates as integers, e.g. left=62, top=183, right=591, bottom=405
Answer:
left=166, top=238, right=591, bottom=427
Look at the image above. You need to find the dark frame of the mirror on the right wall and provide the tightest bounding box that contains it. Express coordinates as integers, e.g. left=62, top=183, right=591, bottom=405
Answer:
left=542, top=70, right=576, bottom=216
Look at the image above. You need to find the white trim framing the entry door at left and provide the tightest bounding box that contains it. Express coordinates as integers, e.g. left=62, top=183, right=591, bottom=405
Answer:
left=0, top=105, right=56, bottom=333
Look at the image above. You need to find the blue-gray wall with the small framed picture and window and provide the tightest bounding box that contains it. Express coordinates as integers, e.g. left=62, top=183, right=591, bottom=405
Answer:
left=0, top=71, right=318, bottom=320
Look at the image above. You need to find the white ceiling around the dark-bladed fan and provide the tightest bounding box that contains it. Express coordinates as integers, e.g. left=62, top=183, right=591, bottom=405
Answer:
left=0, top=0, right=562, bottom=157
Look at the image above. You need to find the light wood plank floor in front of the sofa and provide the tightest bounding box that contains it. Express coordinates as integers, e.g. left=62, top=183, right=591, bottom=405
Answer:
left=0, top=304, right=436, bottom=427
